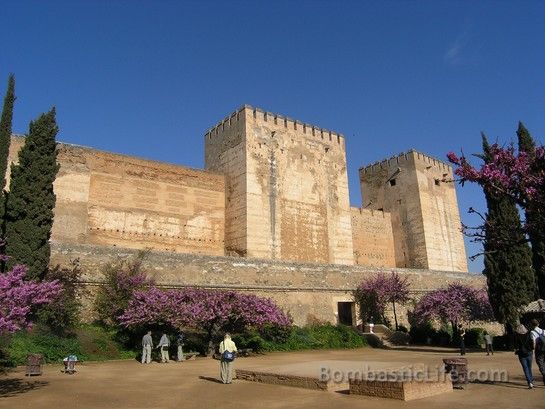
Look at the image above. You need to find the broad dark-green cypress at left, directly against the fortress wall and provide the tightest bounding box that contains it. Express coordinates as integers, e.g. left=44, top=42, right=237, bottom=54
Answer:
left=6, top=108, right=59, bottom=278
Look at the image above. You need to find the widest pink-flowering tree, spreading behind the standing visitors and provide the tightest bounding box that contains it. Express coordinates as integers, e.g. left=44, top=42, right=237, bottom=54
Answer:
left=119, top=287, right=291, bottom=353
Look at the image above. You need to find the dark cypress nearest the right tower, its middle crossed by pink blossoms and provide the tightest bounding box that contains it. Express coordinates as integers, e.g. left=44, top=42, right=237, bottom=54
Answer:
left=481, top=134, right=536, bottom=326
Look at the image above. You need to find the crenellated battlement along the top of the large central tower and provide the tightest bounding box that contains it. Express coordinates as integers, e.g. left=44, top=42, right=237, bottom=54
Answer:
left=205, top=105, right=344, bottom=147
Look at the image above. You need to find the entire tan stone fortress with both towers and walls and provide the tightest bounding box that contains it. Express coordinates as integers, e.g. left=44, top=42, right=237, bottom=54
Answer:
left=6, top=105, right=474, bottom=325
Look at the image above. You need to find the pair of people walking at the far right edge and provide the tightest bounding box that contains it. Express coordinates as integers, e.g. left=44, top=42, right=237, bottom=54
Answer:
left=515, top=320, right=545, bottom=389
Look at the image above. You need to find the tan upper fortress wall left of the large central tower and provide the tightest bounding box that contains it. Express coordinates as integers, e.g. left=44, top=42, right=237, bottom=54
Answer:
left=6, top=137, right=225, bottom=255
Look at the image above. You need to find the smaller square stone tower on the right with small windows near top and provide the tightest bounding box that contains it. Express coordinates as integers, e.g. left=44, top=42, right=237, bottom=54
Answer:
left=360, top=150, right=467, bottom=271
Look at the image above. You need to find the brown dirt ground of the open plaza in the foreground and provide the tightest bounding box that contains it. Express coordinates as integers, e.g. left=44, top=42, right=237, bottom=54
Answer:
left=0, top=348, right=545, bottom=409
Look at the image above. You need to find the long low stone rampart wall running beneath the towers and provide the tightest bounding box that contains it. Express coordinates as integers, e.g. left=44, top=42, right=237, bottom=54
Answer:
left=52, top=243, right=484, bottom=325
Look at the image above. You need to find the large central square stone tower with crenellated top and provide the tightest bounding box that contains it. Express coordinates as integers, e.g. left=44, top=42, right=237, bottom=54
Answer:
left=205, top=105, right=354, bottom=264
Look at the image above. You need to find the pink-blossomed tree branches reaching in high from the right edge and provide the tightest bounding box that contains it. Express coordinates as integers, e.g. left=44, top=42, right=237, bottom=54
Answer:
left=447, top=122, right=545, bottom=298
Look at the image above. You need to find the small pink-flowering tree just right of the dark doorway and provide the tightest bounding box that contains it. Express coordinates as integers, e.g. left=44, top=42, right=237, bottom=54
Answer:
left=355, top=272, right=410, bottom=329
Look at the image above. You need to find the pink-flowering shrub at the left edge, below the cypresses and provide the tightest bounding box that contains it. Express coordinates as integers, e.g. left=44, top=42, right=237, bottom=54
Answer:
left=0, top=265, right=62, bottom=335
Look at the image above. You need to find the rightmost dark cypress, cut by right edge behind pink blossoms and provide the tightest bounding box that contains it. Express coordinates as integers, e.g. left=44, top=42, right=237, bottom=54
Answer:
left=517, top=122, right=545, bottom=299
